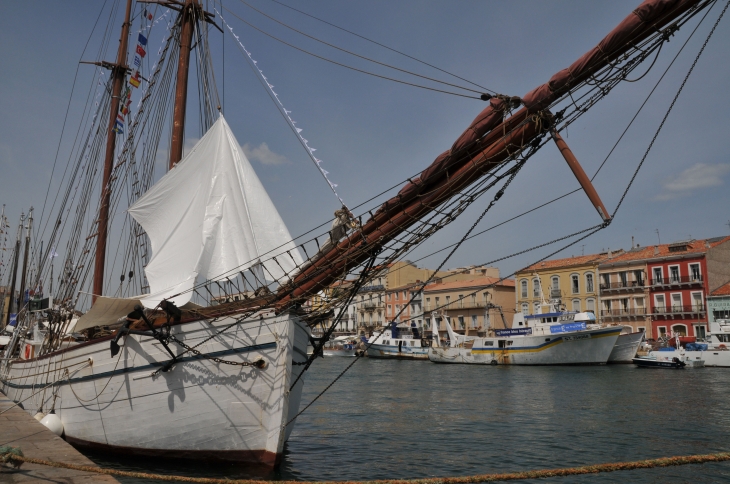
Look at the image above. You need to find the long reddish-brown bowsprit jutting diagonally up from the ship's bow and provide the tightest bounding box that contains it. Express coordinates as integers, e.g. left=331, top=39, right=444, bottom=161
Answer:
left=277, top=0, right=708, bottom=308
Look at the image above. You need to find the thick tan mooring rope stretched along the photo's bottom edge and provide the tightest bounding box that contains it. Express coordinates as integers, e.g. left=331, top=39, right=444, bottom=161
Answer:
left=0, top=446, right=730, bottom=484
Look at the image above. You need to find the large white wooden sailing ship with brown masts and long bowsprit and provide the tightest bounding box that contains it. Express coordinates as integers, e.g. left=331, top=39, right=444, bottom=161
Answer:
left=0, top=0, right=714, bottom=466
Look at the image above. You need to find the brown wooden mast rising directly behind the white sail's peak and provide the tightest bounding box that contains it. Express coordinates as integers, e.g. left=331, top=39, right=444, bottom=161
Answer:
left=169, top=0, right=200, bottom=169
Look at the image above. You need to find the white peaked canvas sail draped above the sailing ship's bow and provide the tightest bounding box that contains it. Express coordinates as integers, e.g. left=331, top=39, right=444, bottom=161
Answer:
left=128, top=116, right=302, bottom=307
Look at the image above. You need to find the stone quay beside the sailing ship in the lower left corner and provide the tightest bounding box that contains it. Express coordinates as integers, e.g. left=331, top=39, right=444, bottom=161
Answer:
left=0, top=393, right=119, bottom=484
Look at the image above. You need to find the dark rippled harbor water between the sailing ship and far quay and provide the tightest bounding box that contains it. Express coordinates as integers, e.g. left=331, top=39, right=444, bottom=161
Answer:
left=89, top=358, right=730, bottom=484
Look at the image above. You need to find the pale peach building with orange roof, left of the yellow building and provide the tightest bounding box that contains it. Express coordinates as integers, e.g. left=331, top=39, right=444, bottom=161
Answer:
left=423, top=274, right=515, bottom=335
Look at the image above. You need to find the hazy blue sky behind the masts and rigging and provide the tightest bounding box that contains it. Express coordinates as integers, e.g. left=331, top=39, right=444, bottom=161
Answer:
left=0, top=0, right=730, bottom=286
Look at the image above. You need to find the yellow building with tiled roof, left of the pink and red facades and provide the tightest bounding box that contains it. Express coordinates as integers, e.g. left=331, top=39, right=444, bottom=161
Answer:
left=515, top=250, right=623, bottom=315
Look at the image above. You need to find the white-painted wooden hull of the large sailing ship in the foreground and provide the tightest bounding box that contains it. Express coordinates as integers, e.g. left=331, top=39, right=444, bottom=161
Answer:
left=2, top=313, right=309, bottom=466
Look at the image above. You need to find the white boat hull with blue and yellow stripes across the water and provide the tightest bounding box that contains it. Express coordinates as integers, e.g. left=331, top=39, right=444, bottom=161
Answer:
left=428, top=327, right=621, bottom=365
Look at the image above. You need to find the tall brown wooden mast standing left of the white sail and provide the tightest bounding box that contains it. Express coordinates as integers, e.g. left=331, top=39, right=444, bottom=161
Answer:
left=91, top=0, right=132, bottom=302
